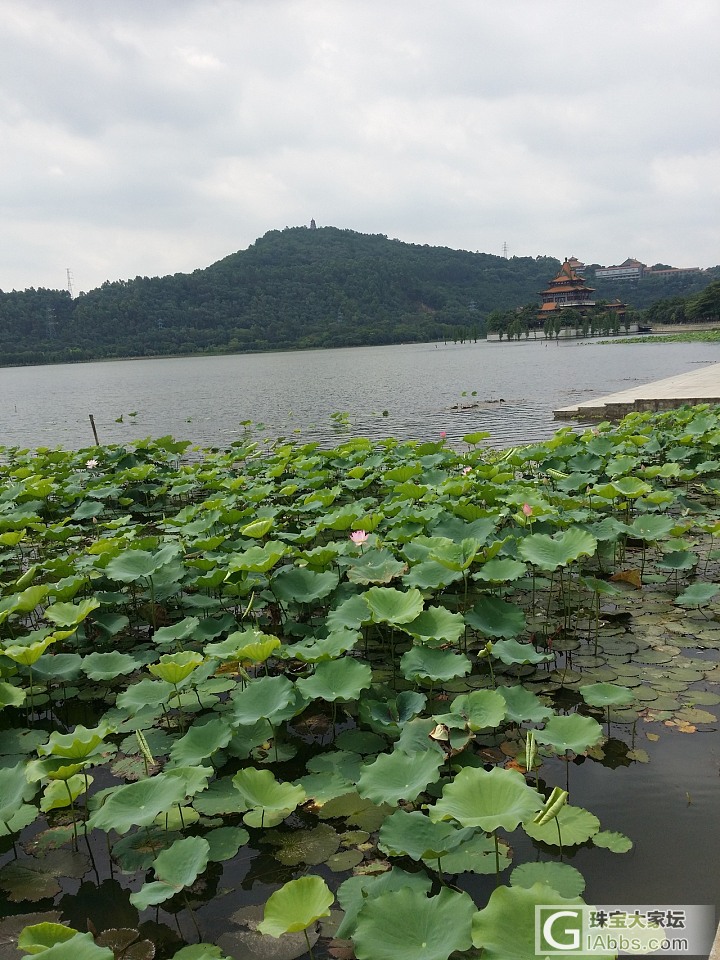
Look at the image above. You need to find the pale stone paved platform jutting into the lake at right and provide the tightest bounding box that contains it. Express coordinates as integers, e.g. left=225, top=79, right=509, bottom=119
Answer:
left=555, top=363, right=720, bottom=420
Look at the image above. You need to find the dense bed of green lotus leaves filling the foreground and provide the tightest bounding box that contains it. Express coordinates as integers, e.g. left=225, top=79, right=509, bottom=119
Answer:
left=0, top=406, right=720, bottom=960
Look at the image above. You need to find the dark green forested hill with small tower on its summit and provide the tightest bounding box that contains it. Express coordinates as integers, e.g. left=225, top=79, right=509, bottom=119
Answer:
left=0, top=227, right=720, bottom=364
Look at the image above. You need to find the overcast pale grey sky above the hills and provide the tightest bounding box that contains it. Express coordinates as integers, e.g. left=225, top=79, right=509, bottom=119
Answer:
left=0, top=0, right=720, bottom=294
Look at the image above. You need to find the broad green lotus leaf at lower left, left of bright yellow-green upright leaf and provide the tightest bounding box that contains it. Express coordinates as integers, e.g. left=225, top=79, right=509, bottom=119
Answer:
left=88, top=773, right=191, bottom=833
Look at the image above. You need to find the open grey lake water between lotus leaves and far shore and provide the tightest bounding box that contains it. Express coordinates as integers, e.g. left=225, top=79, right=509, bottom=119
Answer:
left=0, top=340, right=720, bottom=448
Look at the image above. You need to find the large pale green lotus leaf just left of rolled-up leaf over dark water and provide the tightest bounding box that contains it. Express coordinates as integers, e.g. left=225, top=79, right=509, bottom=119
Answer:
left=428, top=767, right=543, bottom=833
